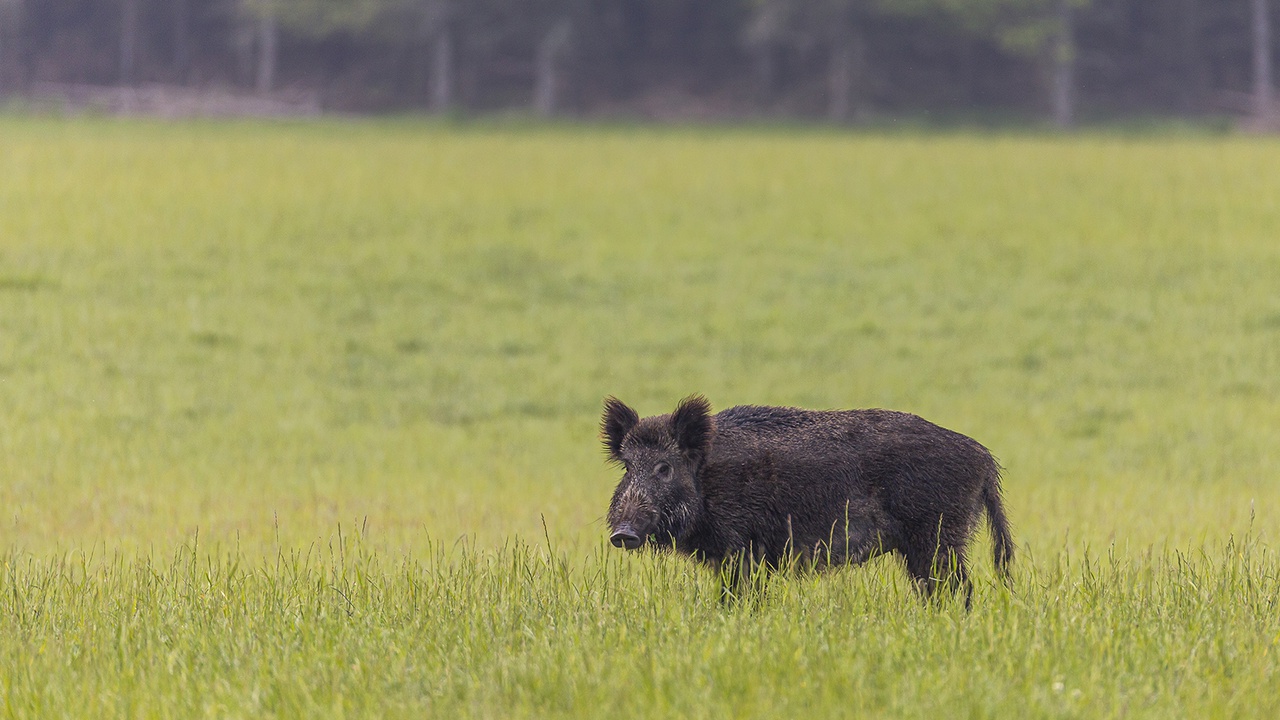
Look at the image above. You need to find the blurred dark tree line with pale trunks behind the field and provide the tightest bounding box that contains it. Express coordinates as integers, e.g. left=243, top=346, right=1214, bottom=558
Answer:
left=0, top=0, right=1275, bottom=126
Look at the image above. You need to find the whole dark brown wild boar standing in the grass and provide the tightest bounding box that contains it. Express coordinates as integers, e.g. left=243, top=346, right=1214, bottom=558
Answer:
left=600, top=396, right=1014, bottom=602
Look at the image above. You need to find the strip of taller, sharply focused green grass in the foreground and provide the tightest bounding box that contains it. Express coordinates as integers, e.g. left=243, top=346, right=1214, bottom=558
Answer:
left=0, top=542, right=1280, bottom=717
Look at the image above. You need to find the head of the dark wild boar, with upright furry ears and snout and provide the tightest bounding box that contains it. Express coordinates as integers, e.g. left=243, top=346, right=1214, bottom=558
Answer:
left=600, top=396, right=714, bottom=550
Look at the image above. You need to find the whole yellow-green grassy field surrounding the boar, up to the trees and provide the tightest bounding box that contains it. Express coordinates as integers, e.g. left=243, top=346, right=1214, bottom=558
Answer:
left=0, top=118, right=1280, bottom=720
